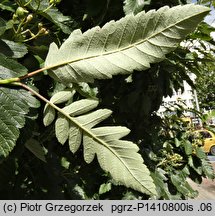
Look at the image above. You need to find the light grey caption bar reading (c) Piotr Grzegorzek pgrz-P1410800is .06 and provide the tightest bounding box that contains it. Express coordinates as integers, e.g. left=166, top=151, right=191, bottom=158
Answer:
left=0, top=200, right=215, bottom=216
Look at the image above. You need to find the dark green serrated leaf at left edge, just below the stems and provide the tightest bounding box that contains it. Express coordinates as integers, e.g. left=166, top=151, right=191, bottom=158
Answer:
left=0, top=87, right=39, bottom=158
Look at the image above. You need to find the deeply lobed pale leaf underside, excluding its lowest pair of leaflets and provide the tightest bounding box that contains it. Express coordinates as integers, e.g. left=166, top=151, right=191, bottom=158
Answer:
left=43, top=99, right=156, bottom=195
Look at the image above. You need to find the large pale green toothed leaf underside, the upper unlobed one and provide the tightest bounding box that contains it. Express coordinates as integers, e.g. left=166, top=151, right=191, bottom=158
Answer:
left=45, top=4, right=209, bottom=84
